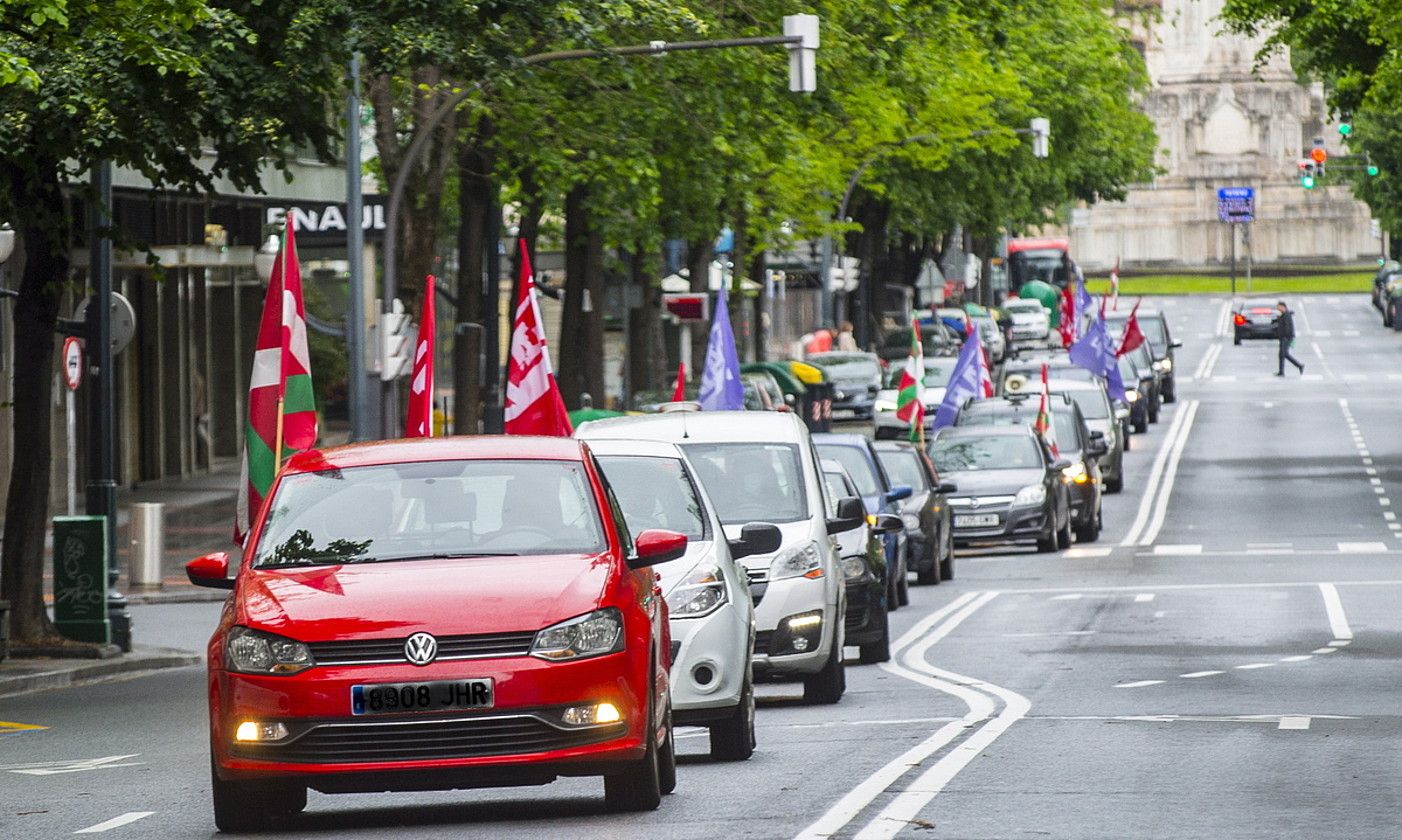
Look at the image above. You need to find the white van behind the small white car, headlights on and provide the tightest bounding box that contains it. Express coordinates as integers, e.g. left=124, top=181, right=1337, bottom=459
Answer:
left=576, top=411, right=866, bottom=703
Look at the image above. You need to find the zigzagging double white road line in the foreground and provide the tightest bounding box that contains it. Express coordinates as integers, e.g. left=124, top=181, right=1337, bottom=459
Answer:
left=795, top=592, right=1032, bottom=840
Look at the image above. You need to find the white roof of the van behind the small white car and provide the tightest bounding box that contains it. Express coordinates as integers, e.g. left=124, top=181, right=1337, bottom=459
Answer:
left=575, top=411, right=808, bottom=443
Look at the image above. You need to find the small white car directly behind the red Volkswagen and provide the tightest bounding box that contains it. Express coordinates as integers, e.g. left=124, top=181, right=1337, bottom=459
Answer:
left=589, top=440, right=780, bottom=760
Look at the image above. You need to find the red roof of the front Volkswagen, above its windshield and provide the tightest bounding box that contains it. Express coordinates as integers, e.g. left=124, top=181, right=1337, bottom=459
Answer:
left=283, top=435, right=587, bottom=473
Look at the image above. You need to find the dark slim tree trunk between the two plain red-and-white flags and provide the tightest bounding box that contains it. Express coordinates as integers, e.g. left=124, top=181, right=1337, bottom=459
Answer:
left=453, top=136, right=492, bottom=435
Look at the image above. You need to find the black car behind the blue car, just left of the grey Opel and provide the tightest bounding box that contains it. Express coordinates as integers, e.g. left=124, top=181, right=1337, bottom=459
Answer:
left=875, top=440, right=956, bottom=583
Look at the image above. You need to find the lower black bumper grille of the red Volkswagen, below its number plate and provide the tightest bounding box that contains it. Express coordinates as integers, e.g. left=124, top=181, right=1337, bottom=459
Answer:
left=233, top=715, right=627, bottom=764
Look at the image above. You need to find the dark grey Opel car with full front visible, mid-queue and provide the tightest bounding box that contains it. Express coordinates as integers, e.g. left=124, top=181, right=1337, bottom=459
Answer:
left=930, top=425, right=1071, bottom=551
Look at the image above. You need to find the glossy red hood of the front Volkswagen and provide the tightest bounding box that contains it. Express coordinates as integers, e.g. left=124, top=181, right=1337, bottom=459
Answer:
left=237, top=554, right=613, bottom=642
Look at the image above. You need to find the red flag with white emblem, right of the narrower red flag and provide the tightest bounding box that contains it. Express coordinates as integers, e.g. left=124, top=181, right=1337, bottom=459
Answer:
left=506, top=240, right=573, bottom=438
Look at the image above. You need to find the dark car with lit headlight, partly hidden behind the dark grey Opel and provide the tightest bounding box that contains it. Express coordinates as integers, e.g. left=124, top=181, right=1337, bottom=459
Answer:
left=955, top=386, right=1109, bottom=543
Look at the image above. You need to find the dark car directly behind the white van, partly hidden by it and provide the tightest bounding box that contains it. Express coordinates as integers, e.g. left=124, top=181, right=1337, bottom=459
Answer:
left=819, top=459, right=900, bottom=663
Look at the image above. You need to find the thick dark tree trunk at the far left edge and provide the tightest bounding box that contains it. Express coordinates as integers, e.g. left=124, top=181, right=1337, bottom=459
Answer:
left=0, top=163, right=69, bottom=645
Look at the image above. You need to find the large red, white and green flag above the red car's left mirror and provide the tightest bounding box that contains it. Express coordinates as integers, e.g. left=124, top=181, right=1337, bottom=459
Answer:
left=234, top=213, right=317, bottom=544
